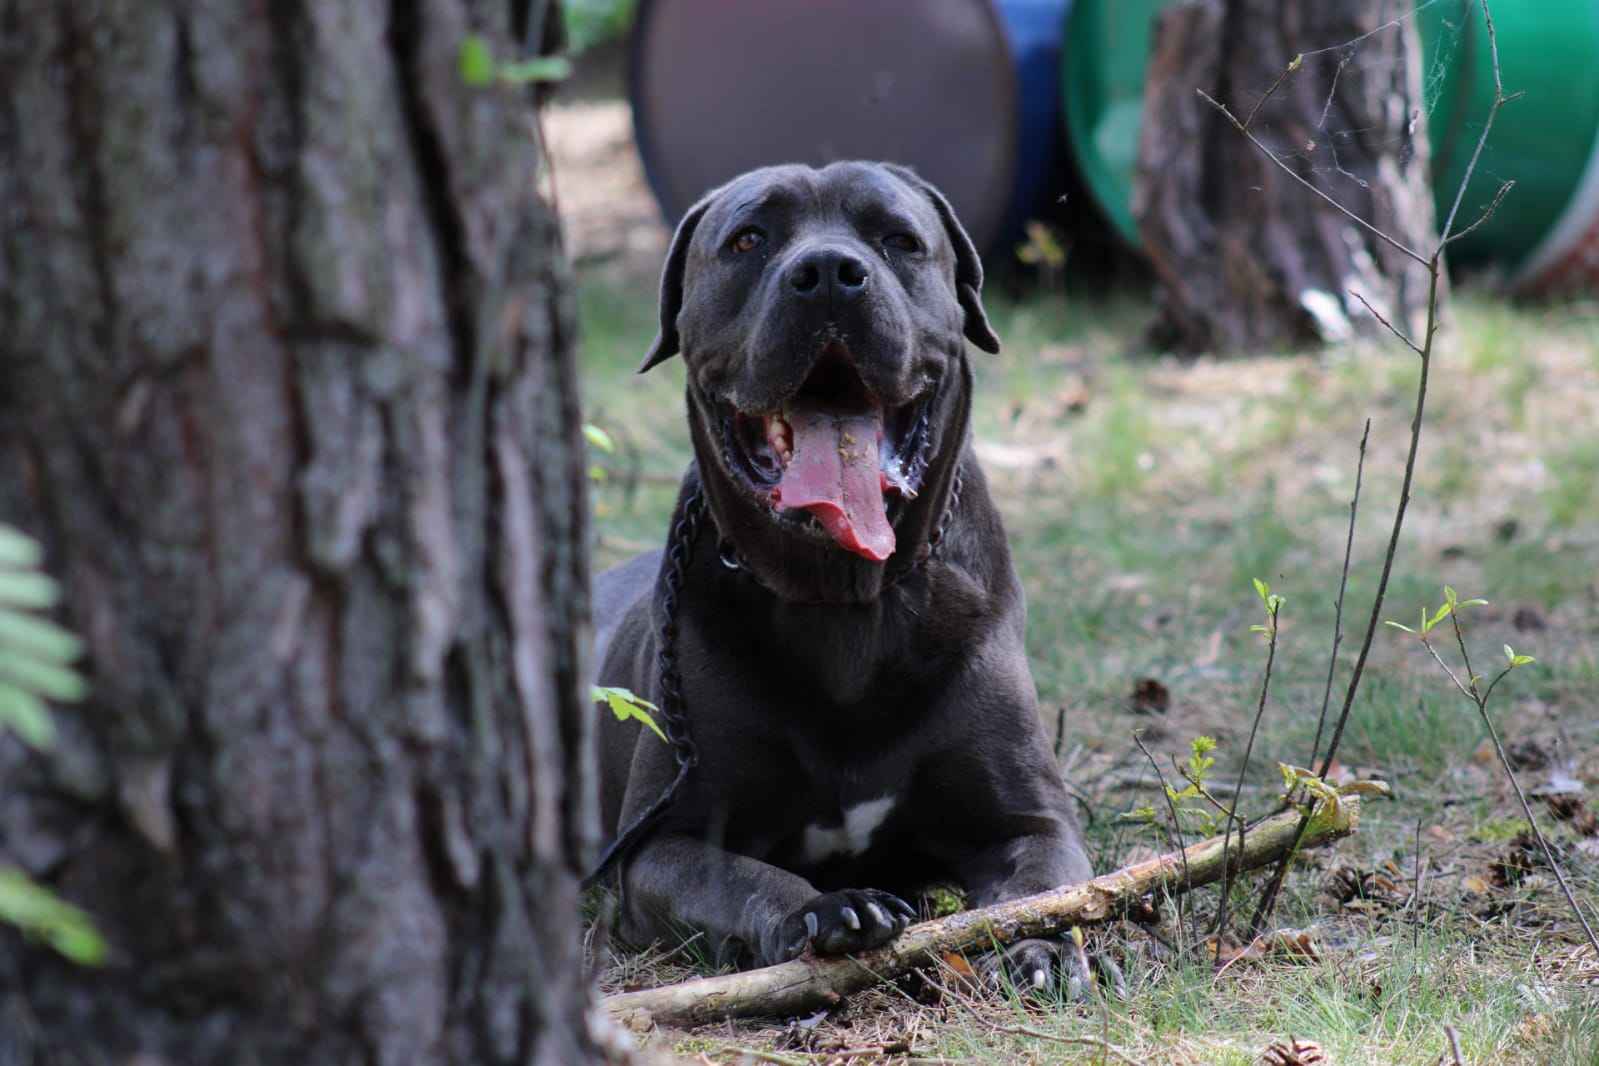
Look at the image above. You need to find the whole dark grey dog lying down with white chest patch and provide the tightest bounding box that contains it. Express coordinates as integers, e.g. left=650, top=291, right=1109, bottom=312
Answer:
left=595, top=163, right=1091, bottom=984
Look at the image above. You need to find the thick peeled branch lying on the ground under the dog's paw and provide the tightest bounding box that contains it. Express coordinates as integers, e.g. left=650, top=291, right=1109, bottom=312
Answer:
left=604, top=786, right=1361, bottom=1029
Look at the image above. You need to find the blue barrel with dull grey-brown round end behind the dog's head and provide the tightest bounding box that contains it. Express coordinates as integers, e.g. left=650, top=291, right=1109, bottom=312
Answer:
left=630, top=0, right=1071, bottom=251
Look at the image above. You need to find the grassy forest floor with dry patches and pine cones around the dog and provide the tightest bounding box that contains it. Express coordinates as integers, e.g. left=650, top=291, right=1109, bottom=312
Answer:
left=552, top=109, right=1599, bottom=1066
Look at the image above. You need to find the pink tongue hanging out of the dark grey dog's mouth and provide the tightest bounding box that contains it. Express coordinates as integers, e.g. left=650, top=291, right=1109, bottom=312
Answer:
left=772, top=408, right=894, bottom=563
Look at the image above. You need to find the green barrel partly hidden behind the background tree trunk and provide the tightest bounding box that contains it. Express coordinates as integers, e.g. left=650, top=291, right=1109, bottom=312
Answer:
left=1062, top=0, right=1599, bottom=291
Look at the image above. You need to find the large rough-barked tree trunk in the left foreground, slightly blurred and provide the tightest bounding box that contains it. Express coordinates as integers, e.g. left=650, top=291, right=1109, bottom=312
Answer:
left=0, top=0, right=595, bottom=1066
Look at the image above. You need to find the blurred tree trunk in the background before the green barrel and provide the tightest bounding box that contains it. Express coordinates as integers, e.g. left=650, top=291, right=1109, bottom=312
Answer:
left=1134, top=0, right=1436, bottom=352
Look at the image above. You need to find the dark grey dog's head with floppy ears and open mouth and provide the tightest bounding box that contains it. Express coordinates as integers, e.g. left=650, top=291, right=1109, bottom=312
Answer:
left=641, top=163, right=999, bottom=599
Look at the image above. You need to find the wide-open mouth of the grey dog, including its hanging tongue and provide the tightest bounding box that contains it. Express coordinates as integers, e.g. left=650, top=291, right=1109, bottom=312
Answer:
left=724, top=344, right=931, bottom=563
